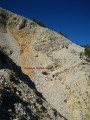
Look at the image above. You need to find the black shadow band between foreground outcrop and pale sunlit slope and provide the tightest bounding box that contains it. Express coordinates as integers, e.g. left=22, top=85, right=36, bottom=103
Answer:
left=0, top=50, right=45, bottom=100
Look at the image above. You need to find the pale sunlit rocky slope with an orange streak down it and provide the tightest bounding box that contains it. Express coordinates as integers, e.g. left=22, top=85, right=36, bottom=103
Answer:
left=0, top=8, right=90, bottom=120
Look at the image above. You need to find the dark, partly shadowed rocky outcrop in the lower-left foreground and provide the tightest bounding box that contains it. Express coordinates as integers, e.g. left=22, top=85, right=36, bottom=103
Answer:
left=0, top=49, right=66, bottom=120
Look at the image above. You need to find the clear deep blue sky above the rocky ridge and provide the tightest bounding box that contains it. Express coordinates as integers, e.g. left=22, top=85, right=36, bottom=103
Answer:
left=0, top=0, right=90, bottom=45
